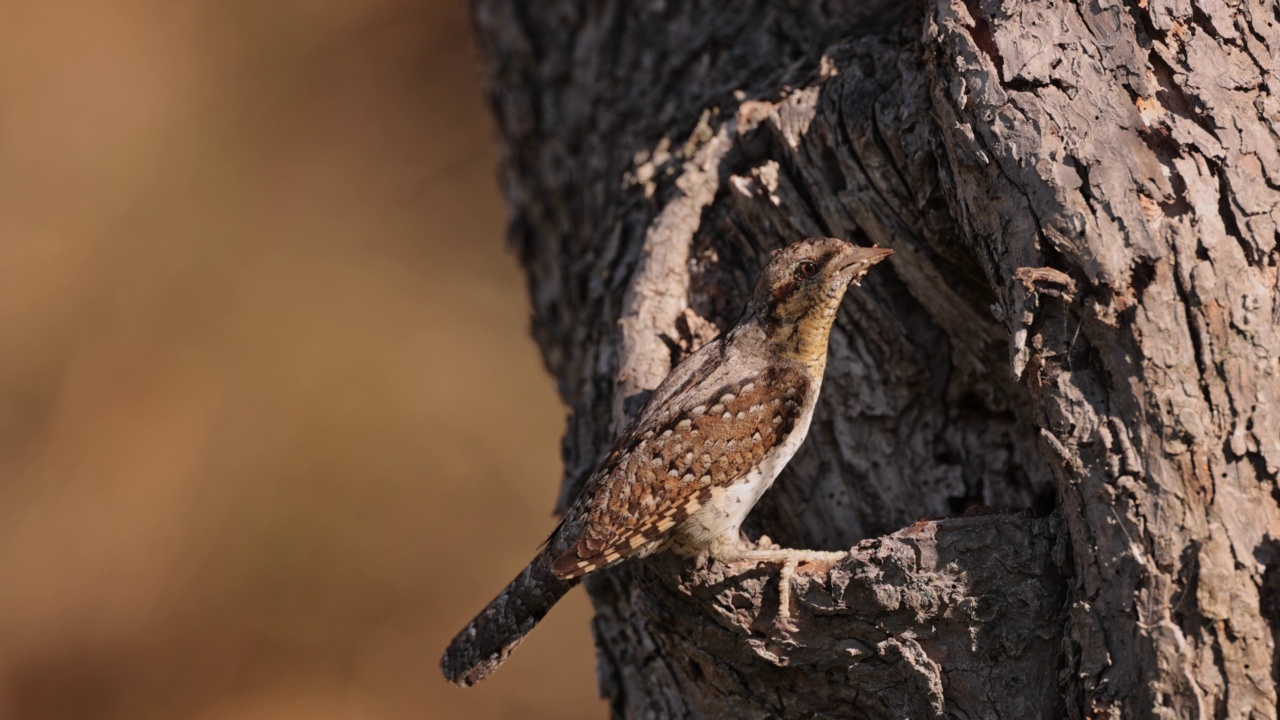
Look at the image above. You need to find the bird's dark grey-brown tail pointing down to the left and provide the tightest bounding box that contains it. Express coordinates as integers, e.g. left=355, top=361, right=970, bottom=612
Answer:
left=440, top=548, right=579, bottom=687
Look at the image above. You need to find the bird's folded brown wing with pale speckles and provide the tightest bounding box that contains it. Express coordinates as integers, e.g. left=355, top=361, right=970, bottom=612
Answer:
left=552, top=366, right=809, bottom=579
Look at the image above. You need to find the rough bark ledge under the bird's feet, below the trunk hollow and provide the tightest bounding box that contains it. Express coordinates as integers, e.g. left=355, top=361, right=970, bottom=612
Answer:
left=593, top=515, right=1066, bottom=717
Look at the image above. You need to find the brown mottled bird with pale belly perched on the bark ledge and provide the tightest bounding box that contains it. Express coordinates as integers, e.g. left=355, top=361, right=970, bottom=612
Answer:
left=440, top=237, right=892, bottom=687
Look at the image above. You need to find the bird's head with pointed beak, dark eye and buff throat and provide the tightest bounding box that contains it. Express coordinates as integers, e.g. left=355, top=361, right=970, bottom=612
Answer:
left=746, top=237, right=893, bottom=363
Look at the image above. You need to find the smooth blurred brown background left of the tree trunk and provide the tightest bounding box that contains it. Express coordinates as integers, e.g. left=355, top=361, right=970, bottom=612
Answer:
left=0, top=0, right=605, bottom=720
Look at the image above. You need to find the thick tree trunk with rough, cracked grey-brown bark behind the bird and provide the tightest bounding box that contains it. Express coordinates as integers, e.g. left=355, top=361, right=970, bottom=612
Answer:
left=475, top=0, right=1280, bottom=719
